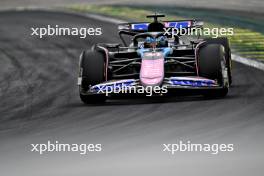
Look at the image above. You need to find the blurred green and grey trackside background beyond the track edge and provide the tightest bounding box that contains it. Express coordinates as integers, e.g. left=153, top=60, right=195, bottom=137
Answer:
left=0, top=0, right=264, bottom=61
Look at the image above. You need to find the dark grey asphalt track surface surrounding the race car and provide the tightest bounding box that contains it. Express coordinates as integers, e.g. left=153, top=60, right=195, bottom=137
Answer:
left=0, top=11, right=264, bottom=176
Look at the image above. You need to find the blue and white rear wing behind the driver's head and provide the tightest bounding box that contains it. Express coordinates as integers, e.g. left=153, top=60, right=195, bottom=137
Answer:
left=118, top=20, right=203, bottom=32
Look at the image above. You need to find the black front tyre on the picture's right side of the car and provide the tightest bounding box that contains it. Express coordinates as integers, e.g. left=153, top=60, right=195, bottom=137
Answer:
left=198, top=44, right=228, bottom=98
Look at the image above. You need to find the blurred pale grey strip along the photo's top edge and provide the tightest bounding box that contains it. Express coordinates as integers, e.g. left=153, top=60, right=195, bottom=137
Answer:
left=1, top=0, right=264, bottom=13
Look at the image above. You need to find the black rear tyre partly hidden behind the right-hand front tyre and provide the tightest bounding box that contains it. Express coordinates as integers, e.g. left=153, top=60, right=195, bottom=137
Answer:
left=205, top=37, right=232, bottom=85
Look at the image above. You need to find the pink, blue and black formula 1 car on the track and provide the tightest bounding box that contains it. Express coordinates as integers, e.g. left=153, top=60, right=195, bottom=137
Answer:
left=78, top=14, right=232, bottom=104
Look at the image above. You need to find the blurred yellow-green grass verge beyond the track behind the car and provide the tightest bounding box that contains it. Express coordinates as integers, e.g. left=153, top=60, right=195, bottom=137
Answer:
left=68, top=5, right=264, bottom=61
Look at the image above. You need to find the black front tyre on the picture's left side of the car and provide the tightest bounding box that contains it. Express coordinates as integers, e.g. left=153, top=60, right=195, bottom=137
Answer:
left=79, top=50, right=106, bottom=104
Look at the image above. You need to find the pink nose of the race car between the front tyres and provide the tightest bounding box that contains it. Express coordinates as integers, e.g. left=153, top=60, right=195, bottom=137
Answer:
left=140, top=56, right=164, bottom=86
